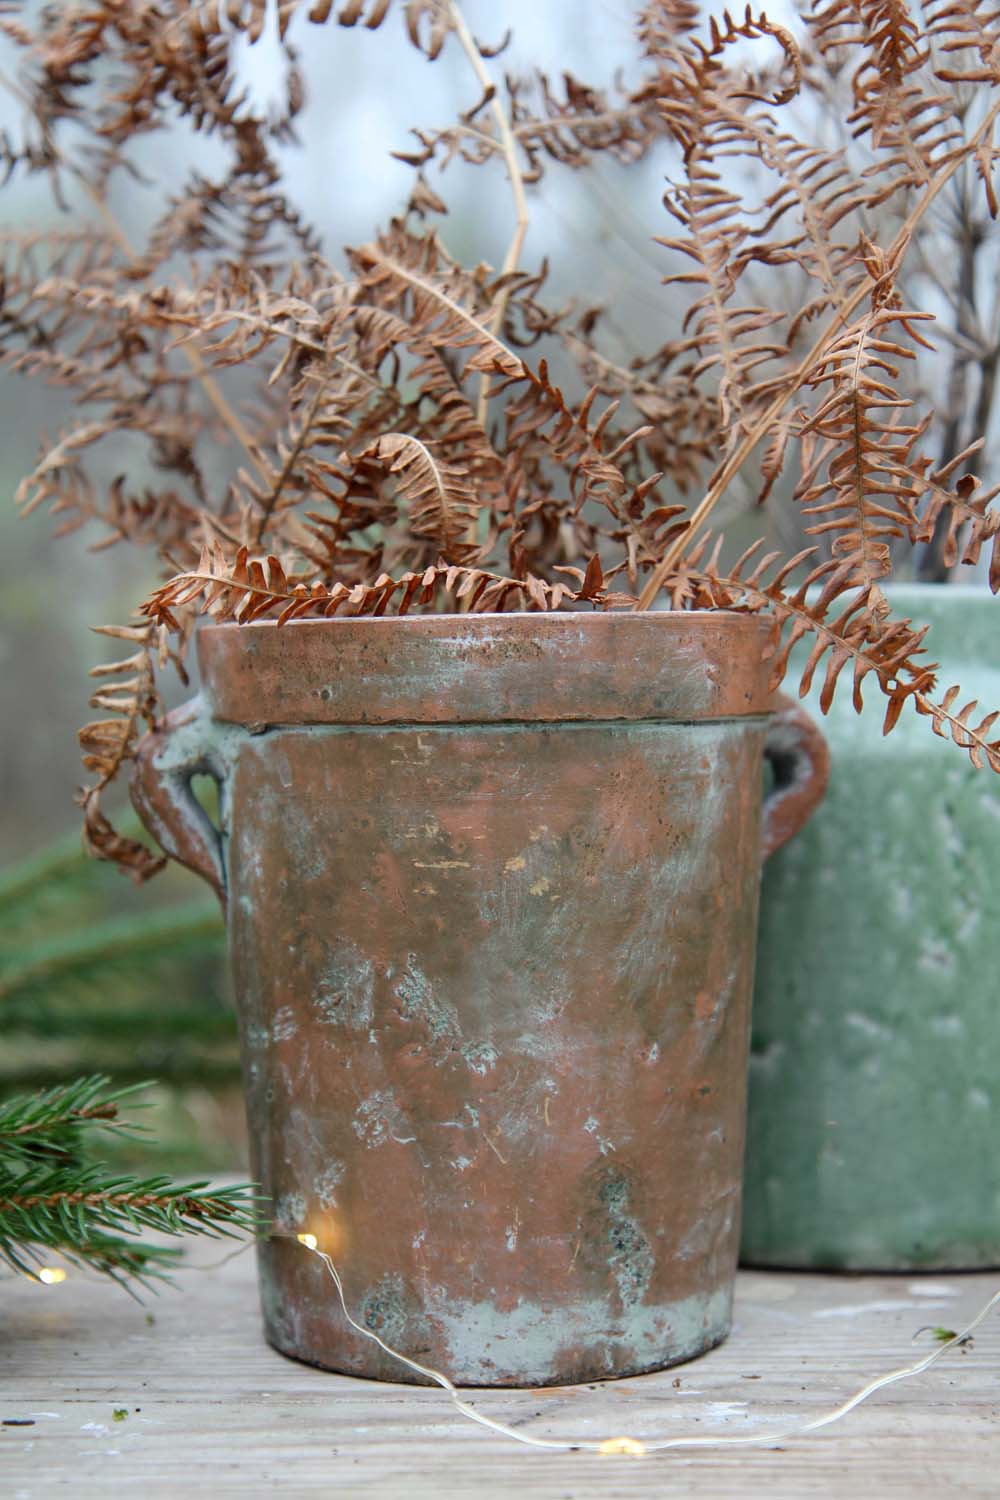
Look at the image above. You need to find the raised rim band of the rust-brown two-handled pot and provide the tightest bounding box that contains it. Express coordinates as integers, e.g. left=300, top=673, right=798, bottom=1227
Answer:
left=198, top=609, right=775, bottom=726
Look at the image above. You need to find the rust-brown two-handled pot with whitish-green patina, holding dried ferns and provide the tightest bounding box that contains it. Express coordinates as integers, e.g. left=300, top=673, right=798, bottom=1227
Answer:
left=133, top=614, right=826, bottom=1385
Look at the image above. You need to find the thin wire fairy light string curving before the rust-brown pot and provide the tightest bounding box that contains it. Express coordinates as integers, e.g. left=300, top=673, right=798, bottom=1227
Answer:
left=284, top=1233, right=1000, bottom=1458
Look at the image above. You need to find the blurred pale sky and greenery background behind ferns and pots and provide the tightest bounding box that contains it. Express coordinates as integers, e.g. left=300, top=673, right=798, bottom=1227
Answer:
left=0, top=0, right=996, bottom=1173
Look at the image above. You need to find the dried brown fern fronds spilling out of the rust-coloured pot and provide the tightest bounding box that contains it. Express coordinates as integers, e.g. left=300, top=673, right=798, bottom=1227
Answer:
left=0, top=0, right=1000, bottom=878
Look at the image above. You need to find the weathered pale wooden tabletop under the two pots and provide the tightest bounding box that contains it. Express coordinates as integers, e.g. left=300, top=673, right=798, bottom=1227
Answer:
left=0, top=1247, right=1000, bottom=1500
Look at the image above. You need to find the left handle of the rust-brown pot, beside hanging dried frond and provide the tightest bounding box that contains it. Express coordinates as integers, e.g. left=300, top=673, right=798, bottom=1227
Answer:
left=130, top=696, right=226, bottom=911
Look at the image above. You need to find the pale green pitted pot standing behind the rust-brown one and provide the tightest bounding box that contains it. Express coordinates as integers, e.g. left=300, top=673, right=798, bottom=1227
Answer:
left=742, top=585, right=1000, bottom=1271
